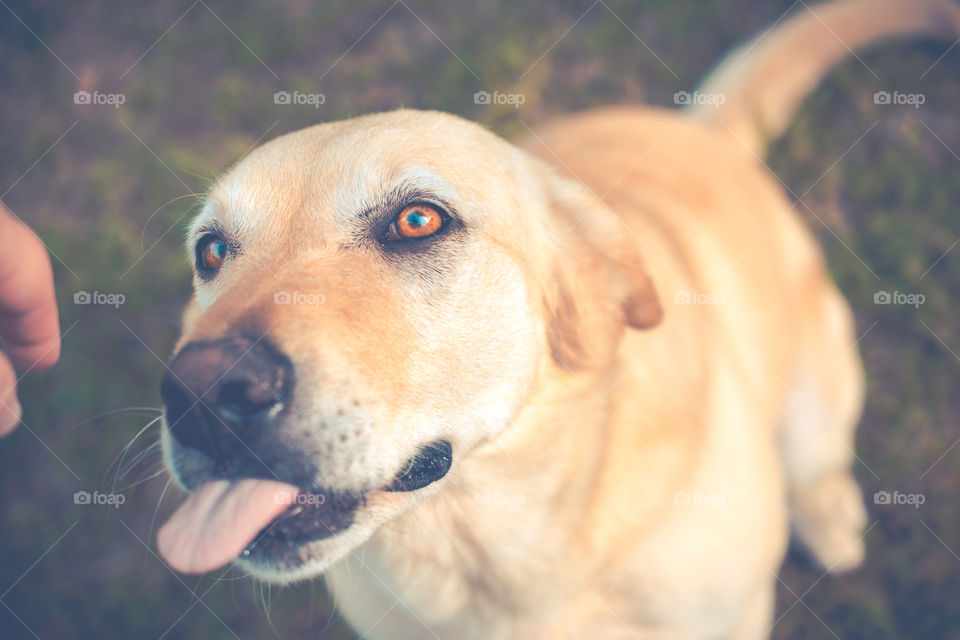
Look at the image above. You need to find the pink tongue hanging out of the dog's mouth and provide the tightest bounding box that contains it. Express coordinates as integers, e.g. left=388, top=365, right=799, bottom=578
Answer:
left=157, top=480, right=299, bottom=573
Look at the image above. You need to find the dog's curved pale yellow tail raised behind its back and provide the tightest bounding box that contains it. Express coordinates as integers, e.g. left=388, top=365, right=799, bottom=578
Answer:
left=687, top=0, right=960, bottom=155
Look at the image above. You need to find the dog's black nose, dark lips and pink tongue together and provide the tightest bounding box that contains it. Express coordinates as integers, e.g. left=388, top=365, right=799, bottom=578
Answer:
left=161, top=336, right=453, bottom=572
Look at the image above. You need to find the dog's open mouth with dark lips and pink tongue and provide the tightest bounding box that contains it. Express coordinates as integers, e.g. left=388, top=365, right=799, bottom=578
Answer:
left=157, top=440, right=452, bottom=573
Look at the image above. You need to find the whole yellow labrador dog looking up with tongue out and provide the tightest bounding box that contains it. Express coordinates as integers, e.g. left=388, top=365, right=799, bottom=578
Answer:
left=158, top=0, right=960, bottom=640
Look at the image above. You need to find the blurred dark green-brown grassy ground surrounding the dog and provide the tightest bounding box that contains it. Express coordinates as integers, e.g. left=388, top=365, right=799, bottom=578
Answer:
left=0, top=0, right=960, bottom=640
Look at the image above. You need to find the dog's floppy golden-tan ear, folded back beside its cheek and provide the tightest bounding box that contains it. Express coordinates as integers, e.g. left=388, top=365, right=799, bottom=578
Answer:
left=544, top=175, right=662, bottom=369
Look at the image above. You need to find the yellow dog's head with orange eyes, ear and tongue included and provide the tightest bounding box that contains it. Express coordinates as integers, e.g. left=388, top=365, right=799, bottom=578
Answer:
left=159, top=111, right=660, bottom=581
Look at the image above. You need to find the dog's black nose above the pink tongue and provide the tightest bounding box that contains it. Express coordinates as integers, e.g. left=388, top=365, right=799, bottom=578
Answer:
left=160, top=336, right=293, bottom=461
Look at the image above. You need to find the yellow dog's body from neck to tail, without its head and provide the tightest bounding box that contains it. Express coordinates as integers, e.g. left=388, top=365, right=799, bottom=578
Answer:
left=340, top=0, right=960, bottom=639
